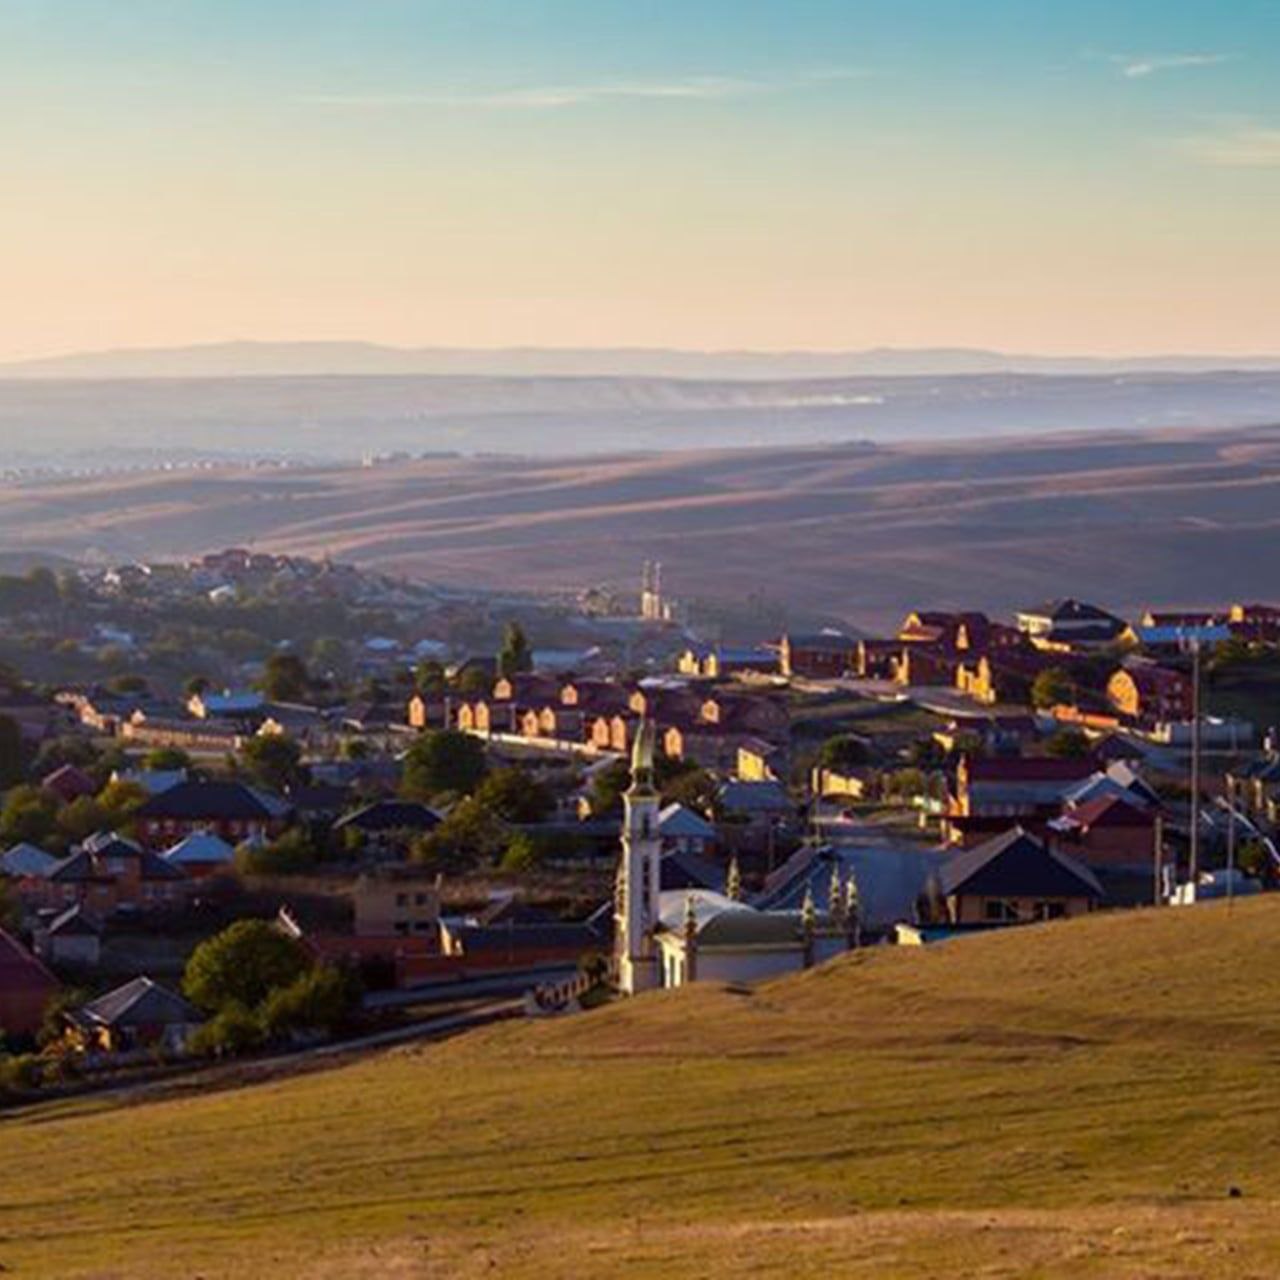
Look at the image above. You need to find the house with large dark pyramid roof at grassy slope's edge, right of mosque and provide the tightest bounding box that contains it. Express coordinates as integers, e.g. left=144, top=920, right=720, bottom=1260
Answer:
left=929, top=827, right=1103, bottom=925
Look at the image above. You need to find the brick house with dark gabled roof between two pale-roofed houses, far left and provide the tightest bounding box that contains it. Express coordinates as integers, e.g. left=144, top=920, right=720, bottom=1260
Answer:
left=38, top=831, right=187, bottom=918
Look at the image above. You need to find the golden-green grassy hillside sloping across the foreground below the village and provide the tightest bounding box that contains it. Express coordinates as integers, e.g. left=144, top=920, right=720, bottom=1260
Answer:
left=0, top=900, right=1280, bottom=1277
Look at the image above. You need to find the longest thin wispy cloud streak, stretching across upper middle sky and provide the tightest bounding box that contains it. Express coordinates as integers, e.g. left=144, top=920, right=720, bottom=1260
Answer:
left=302, top=68, right=867, bottom=111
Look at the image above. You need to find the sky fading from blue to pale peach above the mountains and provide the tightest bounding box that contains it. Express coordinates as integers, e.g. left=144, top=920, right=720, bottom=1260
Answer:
left=0, top=0, right=1280, bottom=360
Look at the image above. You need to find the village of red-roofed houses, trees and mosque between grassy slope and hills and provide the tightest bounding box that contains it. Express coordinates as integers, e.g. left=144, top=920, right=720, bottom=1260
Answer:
left=0, top=550, right=1280, bottom=1100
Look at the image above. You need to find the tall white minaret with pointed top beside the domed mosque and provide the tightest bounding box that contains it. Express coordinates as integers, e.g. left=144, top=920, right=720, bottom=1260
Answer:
left=613, top=719, right=662, bottom=996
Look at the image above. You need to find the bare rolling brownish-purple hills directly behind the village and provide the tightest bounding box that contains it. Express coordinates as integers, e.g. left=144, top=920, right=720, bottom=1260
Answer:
left=0, top=428, right=1280, bottom=627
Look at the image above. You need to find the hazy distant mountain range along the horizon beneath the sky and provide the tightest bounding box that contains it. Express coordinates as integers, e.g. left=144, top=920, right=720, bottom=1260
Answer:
left=0, top=342, right=1280, bottom=379
